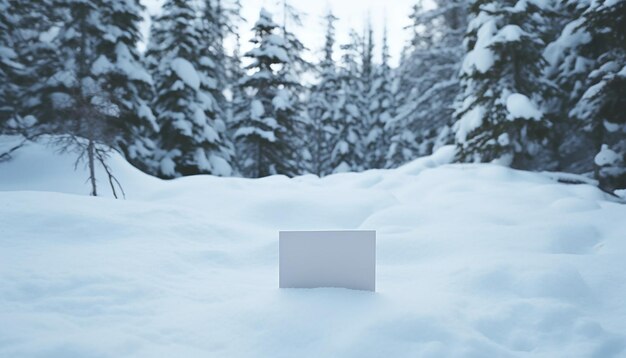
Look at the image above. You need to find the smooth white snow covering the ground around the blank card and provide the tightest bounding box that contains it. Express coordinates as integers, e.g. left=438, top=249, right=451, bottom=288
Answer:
left=0, top=139, right=626, bottom=358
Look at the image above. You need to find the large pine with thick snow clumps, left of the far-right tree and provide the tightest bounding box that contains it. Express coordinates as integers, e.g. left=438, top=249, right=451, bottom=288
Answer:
left=454, top=0, right=552, bottom=169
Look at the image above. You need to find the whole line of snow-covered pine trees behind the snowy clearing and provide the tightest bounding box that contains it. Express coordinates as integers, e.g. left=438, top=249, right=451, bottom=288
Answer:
left=0, top=0, right=626, bottom=190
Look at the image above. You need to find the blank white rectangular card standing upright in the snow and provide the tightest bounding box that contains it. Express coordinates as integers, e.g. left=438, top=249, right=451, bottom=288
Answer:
left=279, top=231, right=376, bottom=291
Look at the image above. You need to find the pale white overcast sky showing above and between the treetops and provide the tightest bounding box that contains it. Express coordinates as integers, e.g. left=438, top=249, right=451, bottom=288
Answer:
left=142, top=0, right=424, bottom=64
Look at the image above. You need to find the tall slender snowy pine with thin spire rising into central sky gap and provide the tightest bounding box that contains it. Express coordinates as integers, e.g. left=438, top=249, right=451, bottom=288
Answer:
left=306, top=11, right=339, bottom=176
